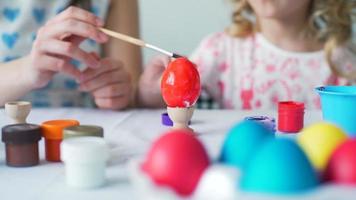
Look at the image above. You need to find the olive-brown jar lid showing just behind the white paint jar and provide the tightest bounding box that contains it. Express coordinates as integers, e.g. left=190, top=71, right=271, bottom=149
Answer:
left=63, top=125, right=104, bottom=139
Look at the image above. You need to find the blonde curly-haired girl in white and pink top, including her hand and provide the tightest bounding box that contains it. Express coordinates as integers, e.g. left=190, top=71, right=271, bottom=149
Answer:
left=139, top=0, right=356, bottom=109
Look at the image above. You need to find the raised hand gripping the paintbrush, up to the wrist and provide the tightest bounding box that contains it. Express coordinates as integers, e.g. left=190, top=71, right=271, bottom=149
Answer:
left=25, top=7, right=108, bottom=88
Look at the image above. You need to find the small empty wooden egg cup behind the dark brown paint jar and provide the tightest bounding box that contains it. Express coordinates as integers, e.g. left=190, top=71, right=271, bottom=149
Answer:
left=5, top=101, right=31, bottom=124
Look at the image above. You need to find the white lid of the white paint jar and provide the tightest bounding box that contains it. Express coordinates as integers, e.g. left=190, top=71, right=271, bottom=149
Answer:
left=60, top=136, right=109, bottom=163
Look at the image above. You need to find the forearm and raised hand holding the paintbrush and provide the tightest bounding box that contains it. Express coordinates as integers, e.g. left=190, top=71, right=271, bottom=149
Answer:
left=0, top=7, right=108, bottom=106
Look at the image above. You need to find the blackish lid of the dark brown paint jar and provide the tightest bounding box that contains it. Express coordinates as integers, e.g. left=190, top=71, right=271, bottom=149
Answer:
left=2, top=124, right=41, bottom=144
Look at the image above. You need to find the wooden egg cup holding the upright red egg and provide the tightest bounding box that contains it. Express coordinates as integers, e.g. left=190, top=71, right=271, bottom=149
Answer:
left=167, top=106, right=194, bottom=131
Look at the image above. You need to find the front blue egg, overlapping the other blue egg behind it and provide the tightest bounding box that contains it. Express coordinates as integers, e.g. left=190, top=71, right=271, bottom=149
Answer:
left=239, top=138, right=318, bottom=194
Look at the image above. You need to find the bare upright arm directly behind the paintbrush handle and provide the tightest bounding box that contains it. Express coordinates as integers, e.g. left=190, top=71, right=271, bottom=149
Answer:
left=104, top=0, right=142, bottom=105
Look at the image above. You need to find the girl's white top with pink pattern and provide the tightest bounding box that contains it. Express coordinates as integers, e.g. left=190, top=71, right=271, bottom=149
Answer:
left=191, top=33, right=355, bottom=110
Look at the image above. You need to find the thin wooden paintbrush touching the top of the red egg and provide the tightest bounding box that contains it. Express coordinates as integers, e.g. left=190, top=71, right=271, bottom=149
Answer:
left=99, top=28, right=182, bottom=58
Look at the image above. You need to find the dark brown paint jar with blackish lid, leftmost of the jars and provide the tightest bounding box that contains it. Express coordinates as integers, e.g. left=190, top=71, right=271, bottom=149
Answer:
left=2, top=124, right=41, bottom=167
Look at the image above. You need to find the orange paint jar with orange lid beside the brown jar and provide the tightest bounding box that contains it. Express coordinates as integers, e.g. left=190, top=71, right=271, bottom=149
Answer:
left=41, top=119, right=79, bottom=162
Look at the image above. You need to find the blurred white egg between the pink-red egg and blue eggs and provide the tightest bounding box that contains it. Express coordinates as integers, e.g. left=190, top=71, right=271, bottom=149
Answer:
left=194, top=165, right=240, bottom=200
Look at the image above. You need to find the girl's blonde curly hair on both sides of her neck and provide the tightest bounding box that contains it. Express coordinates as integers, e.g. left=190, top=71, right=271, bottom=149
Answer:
left=227, top=0, right=356, bottom=80
